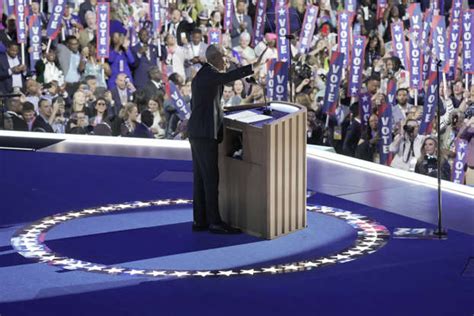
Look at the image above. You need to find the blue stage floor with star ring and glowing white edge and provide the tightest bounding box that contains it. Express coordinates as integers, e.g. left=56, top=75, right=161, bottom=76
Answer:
left=0, top=132, right=474, bottom=316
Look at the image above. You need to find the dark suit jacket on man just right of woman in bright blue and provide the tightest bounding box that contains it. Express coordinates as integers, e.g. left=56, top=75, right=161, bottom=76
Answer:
left=132, top=43, right=167, bottom=89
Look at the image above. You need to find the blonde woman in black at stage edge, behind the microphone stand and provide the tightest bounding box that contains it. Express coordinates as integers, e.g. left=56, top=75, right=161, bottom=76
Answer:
left=415, top=136, right=451, bottom=180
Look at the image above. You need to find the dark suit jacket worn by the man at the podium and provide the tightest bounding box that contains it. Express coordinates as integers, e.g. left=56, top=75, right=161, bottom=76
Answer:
left=188, top=63, right=253, bottom=140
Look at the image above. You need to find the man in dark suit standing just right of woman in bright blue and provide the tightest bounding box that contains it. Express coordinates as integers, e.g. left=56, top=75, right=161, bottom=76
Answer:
left=132, top=28, right=167, bottom=89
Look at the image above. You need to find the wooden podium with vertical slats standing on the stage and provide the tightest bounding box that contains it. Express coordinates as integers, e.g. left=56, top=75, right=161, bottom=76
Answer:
left=219, top=102, right=307, bottom=239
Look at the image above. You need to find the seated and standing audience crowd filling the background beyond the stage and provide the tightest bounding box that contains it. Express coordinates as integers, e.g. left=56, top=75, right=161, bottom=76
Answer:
left=0, top=0, right=474, bottom=185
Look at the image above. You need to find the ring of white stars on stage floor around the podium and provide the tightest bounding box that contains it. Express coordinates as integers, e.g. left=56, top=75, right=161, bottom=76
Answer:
left=11, top=199, right=390, bottom=278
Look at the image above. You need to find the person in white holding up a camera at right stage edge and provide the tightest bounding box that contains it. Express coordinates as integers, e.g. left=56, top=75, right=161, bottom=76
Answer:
left=390, top=119, right=424, bottom=171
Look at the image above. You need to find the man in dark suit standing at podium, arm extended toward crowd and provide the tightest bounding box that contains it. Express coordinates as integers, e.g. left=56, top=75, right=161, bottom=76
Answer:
left=188, top=45, right=263, bottom=234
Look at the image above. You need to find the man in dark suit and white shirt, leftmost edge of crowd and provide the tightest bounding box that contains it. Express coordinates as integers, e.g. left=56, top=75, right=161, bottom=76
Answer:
left=0, top=42, right=27, bottom=94
